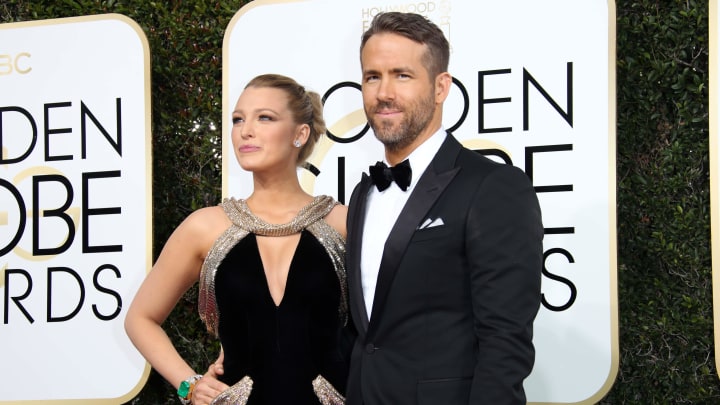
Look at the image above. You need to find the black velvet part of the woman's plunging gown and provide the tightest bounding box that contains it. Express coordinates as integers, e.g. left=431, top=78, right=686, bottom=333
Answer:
left=202, top=195, right=348, bottom=405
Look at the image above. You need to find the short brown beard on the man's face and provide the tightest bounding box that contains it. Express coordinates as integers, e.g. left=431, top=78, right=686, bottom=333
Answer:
left=367, top=93, right=435, bottom=151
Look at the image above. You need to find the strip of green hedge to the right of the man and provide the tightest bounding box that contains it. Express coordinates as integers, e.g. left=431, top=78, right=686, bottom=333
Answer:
left=607, top=0, right=720, bottom=404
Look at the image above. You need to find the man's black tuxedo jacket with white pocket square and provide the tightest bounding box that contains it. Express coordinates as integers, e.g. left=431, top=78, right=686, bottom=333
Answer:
left=347, top=134, right=543, bottom=405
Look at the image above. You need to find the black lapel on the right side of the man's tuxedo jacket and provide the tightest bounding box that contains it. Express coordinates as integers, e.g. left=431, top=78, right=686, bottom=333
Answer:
left=366, top=134, right=461, bottom=336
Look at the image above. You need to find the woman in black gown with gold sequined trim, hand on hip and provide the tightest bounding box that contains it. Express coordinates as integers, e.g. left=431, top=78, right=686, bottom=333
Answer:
left=125, top=75, right=347, bottom=405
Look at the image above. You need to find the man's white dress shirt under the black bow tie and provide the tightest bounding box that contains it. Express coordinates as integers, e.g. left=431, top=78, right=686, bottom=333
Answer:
left=360, top=127, right=447, bottom=319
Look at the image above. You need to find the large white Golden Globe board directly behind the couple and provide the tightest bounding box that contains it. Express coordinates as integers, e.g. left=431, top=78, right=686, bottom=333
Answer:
left=223, top=0, right=618, bottom=403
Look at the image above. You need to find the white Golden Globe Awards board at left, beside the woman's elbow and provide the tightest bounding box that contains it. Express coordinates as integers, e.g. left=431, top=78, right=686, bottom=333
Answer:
left=0, top=15, right=152, bottom=404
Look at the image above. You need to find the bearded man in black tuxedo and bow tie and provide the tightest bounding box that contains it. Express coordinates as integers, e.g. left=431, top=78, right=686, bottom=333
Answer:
left=347, top=12, right=543, bottom=405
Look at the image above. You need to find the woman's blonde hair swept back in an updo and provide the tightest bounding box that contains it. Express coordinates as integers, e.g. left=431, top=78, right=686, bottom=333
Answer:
left=245, top=74, right=327, bottom=166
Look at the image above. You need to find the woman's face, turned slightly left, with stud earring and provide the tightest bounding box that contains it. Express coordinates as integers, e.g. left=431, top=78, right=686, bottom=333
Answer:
left=232, top=87, right=307, bottom=172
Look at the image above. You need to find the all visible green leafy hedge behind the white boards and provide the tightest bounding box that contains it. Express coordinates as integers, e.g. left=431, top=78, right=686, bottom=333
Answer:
left=0, top=0, right=720, bottom=404
